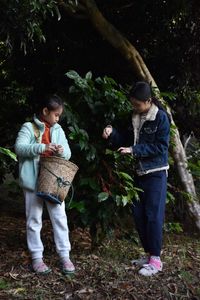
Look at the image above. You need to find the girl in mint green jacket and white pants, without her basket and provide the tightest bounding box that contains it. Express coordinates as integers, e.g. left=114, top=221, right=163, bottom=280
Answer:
left=15, top=95, right=75, bottom=274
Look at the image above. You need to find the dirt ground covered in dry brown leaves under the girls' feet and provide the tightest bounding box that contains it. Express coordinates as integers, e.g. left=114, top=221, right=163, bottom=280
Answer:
left=0, top=215, right=200, bottom=300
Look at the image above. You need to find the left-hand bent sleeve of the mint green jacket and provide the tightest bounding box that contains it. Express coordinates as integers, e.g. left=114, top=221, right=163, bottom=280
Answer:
left=15, top=122, right=45, bottom=158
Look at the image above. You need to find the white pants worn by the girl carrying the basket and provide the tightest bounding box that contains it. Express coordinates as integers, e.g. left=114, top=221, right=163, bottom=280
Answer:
left=24, top=190, right=71, bottom=259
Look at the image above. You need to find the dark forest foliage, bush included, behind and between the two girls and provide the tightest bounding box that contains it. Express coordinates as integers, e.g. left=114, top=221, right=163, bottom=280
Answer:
left=0, top=0, right=200, bottom=298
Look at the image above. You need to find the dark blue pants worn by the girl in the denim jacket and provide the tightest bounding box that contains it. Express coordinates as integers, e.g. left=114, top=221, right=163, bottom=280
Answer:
left=133, top=171, right=167, bottom=256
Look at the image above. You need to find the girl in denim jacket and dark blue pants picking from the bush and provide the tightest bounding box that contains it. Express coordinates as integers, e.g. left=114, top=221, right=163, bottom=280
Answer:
left=103, top=82, right=170, bottom=276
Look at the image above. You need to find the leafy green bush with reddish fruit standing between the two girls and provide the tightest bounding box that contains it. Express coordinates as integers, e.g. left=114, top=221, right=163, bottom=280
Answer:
left=63, top=71, right=141, bottom=241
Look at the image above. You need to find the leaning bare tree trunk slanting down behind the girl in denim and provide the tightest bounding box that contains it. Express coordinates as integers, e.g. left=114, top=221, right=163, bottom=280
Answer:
left=59, top=0, right=200, bottom=231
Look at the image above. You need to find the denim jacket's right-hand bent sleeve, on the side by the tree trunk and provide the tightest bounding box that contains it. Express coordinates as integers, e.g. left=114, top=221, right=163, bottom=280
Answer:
left=132, top=113, right=170, bottom=158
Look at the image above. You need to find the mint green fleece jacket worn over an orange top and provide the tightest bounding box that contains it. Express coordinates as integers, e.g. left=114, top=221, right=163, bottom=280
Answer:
left=15, top=116, right=71, bottom=191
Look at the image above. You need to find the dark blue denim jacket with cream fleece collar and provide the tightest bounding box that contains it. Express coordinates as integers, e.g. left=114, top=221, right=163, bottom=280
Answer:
left=109, top=104, right=170, bottom=175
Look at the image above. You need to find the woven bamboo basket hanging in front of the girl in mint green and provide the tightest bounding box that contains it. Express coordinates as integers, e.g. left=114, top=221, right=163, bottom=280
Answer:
left=37, top=156, right=78, bottom=204
